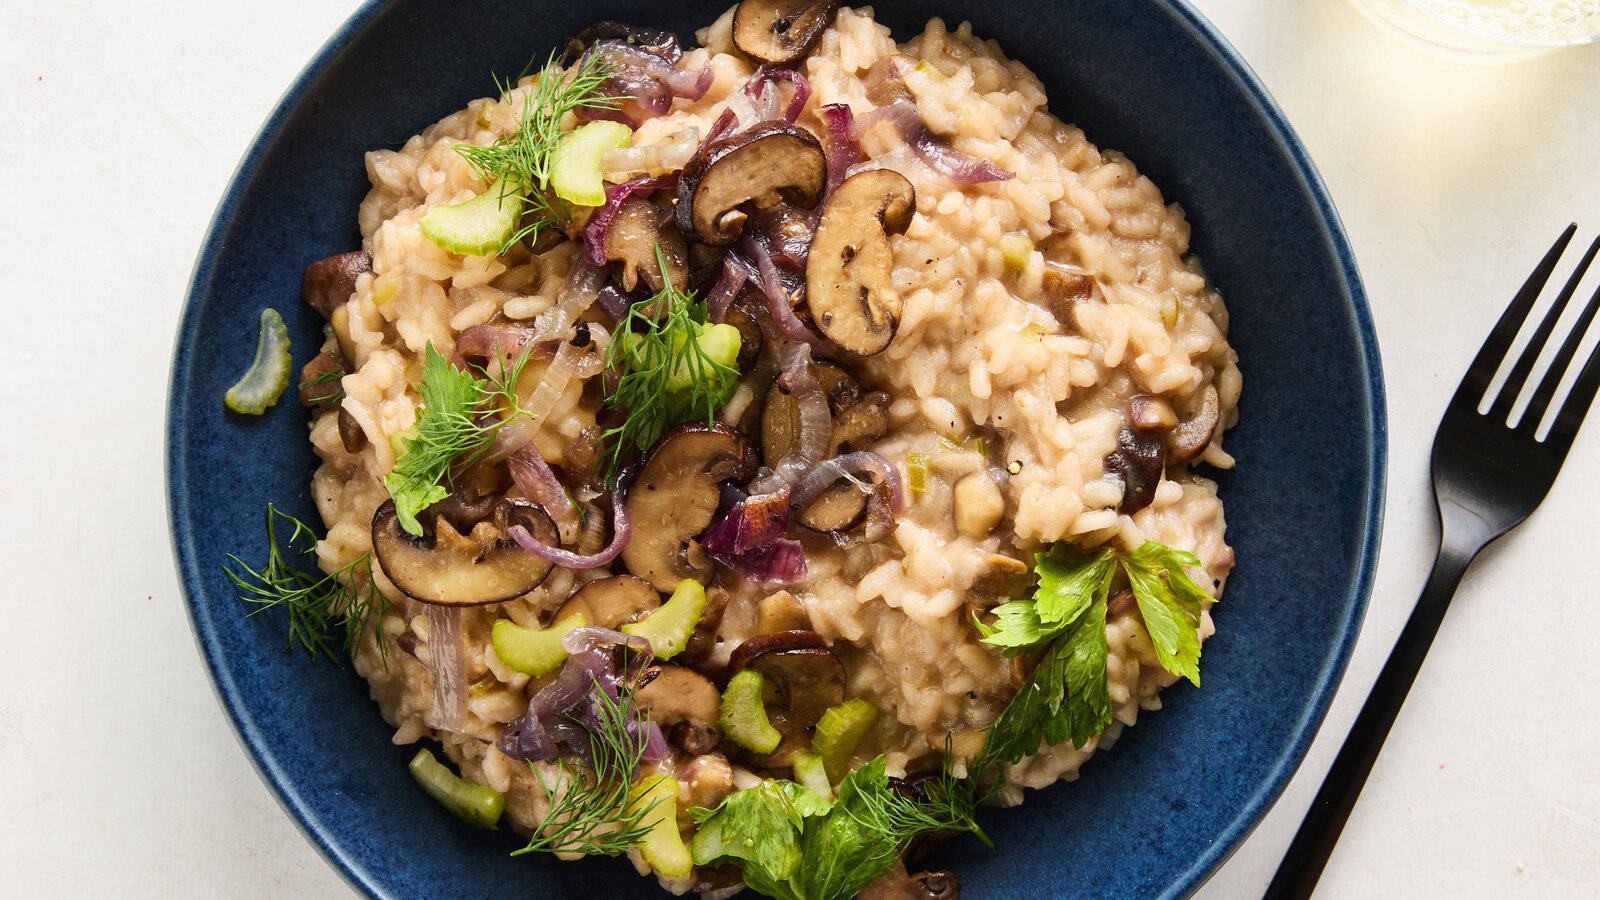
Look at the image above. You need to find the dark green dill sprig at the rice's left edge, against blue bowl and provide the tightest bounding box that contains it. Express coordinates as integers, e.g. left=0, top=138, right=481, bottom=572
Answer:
left=222, top=503, right=389, bottom=665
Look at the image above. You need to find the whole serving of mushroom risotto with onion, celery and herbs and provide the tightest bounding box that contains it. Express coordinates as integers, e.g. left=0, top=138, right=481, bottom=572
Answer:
left=284, top=0, right=1240, bottom=897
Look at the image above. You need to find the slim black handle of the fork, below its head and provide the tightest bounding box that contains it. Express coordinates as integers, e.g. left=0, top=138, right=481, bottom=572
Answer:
left=1264, top=524, right=1482, bottom=900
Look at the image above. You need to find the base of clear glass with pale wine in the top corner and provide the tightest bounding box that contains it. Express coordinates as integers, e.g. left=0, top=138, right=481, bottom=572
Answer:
left=1355, top=0, right=1600, bottom=53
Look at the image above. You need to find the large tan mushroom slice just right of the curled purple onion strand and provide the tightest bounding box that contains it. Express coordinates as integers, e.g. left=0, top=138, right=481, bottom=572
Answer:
left=622, top=423, right=757, bottom=591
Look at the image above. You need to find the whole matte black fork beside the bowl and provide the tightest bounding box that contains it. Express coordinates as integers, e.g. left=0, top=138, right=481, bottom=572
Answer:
left=1266, top=224, right=1600, bottom=900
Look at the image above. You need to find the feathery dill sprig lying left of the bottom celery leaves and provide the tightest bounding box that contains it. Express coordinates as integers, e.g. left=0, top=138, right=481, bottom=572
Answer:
left=512, top=672, right=661, bottom=857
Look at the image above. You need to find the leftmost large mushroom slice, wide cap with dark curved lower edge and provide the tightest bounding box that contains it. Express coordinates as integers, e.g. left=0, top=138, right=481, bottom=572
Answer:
left=373, top=500, right=558, bottom=607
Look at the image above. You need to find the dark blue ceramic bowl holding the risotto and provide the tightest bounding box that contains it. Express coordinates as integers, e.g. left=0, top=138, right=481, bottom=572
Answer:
left=166, top=0, right=1386, bottom=900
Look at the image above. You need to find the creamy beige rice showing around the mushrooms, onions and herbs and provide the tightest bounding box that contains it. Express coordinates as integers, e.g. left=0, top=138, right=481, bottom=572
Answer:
left=310, top=8, right=1240, bottom=890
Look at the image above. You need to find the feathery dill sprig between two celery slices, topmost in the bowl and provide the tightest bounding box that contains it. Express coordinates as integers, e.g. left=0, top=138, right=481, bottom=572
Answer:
left=456, top=53, right=618, bottom=255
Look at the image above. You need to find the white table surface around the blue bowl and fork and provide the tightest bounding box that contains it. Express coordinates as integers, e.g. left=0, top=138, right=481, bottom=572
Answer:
left=0, top=0, right=1600, bottom=900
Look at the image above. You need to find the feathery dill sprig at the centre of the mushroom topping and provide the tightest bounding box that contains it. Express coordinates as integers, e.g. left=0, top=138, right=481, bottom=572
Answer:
left=602, top=243, right=739, bottom=472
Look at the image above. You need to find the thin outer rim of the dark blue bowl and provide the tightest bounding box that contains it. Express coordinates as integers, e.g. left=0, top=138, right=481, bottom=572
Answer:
left=163, top=0, right=1389, bottom=900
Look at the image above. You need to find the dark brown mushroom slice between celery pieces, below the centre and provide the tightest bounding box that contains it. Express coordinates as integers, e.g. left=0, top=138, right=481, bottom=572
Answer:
left=728, top=631, right=845, bottom=737
